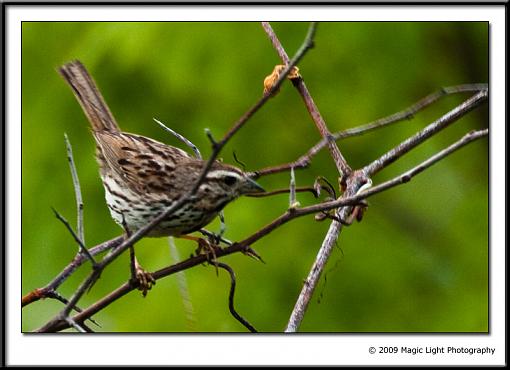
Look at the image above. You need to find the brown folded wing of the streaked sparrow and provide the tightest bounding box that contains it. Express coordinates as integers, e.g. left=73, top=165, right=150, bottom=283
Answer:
left=93, top=131, right=191, bottom=193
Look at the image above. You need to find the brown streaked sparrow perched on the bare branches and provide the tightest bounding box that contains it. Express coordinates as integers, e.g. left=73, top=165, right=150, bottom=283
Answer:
left=59, top=61, right=263, bottom=236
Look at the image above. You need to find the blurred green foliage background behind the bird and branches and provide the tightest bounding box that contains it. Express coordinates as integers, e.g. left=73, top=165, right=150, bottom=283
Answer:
left=21, top=22, right=488, bottom=332
